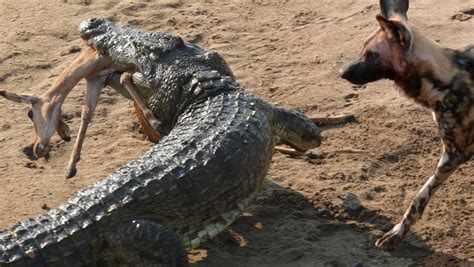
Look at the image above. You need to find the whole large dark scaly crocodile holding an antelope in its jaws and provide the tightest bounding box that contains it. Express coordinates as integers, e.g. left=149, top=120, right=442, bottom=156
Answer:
left=0, top=18, right=321, bottom=266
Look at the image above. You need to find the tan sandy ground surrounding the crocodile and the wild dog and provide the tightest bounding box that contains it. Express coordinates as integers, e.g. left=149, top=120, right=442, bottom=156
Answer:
left=0, top=0, right=474, bottom=266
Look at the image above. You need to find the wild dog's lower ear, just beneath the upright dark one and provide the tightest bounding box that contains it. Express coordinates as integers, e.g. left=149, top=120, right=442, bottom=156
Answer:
left=376, top=15, right=413, bottom=50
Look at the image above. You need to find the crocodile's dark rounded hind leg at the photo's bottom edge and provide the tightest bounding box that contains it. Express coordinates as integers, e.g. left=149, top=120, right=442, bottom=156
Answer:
left=101, top=220, right=188, bottom=267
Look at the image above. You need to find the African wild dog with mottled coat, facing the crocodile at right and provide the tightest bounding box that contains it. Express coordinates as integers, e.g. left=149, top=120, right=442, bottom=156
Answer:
left=341, top=0, right=474, bottom=250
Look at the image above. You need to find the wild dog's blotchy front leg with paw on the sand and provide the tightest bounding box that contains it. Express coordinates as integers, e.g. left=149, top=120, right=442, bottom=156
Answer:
left=375, top=152, right=463, bottom=250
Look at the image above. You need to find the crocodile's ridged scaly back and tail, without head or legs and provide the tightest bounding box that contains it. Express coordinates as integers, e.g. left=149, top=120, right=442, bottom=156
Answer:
left=0, top=90, right=274, bottom=267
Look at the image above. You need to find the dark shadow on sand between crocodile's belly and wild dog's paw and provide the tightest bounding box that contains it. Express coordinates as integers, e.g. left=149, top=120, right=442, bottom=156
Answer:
left=190, top=181, right=470, bottom=267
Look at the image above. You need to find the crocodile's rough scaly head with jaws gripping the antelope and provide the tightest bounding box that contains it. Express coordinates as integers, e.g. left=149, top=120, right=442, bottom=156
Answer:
left=79, top=18, right=233, bottom=131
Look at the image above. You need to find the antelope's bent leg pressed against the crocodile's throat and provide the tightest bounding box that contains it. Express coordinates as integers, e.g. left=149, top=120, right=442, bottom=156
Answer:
left=120, top=72, right=166, bottom=138
